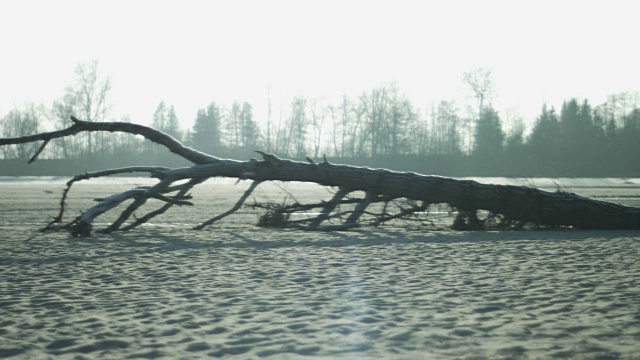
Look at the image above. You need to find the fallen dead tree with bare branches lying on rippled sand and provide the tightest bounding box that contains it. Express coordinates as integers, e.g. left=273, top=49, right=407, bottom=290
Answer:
left=0, top=117, right=640, bottom=236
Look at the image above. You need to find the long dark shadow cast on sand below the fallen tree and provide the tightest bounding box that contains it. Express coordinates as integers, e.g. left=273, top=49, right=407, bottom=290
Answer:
left=5, top=228, right=634, bottom=264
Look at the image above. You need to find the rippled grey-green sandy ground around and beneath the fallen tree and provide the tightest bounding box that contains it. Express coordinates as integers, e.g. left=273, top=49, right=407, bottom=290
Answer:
left=0, top=182, right=640, bottom=359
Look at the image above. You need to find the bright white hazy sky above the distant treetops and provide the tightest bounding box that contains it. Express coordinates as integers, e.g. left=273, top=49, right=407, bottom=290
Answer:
left=0, top=0, right=640, bottom=127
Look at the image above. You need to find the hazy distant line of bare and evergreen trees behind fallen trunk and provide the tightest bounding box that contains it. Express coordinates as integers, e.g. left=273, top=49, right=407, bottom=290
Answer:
left=0, top=62, right=640, bottom=176
